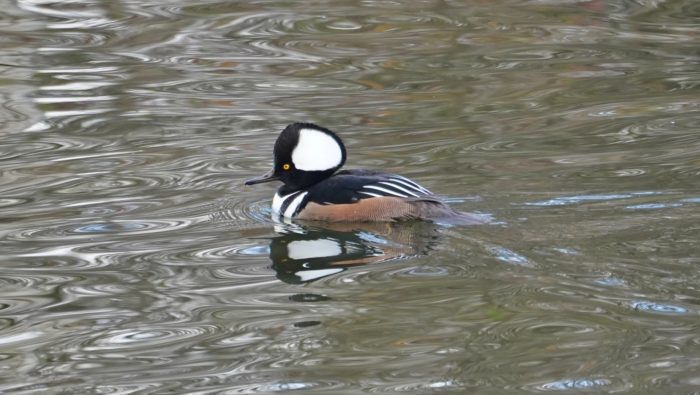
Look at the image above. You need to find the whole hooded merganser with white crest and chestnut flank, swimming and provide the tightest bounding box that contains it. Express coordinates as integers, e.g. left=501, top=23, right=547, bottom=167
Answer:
left=245, top=123, right=487, bottom=225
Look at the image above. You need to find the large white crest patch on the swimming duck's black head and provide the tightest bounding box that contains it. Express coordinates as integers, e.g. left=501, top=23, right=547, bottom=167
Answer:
left=292, top=128, right=343, bottom=171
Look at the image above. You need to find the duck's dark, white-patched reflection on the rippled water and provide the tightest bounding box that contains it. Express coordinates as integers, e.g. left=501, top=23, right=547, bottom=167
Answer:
left=270, top=221, right=438, bottom=284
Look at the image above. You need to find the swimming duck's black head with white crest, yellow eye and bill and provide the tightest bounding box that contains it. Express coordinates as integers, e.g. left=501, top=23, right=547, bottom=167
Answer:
left=245, top=123, right=346, bottom=191
